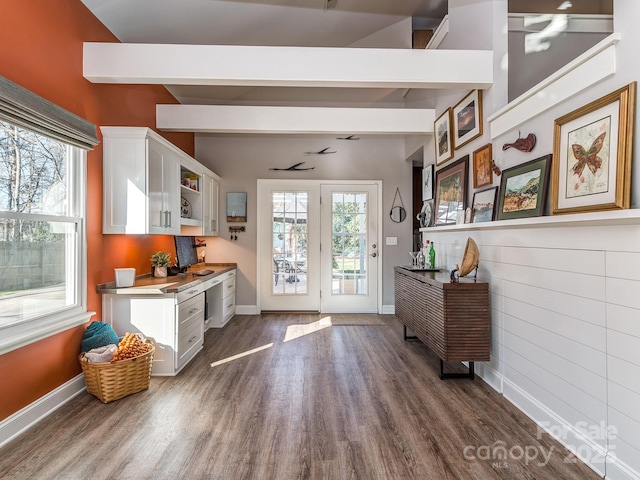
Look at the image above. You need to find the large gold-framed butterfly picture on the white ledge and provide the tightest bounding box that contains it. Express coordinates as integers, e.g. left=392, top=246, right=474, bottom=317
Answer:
left=551, top=82, right=636, bottom=215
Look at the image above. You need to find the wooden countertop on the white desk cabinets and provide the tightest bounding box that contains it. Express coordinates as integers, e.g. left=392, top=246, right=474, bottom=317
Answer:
left=96, top=263, right=237, bottom=295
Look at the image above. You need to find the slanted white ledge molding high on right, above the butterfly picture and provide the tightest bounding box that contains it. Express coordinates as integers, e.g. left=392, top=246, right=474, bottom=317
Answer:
left=488, top=33, right=621, bottom=140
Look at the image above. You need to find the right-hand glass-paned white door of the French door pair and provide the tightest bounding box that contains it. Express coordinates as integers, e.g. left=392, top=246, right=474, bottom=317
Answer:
left=320, top=184, right=380, bottom=313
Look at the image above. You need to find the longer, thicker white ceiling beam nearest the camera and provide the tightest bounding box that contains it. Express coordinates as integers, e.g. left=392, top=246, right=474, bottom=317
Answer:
left=83, top=42, right=493, bottom=89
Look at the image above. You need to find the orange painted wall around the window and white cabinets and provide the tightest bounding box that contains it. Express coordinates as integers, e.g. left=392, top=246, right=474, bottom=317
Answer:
left=0, top=0, right=194, bottom=420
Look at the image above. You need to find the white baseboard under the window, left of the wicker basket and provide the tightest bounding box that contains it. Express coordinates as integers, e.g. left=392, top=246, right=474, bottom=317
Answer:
left=0, top=374, right=85, bottom=447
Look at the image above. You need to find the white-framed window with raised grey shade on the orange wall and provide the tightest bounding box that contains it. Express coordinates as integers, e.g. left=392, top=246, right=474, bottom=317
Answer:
left=0, top=77, right=97, bottom=354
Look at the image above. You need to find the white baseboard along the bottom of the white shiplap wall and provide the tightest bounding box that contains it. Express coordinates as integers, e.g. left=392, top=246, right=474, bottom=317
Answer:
left=502, top=378, right=614, bottom=478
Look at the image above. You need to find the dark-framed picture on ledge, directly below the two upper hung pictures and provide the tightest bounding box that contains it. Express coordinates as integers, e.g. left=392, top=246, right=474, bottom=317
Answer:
left=434, top=155, right=469, bottom=225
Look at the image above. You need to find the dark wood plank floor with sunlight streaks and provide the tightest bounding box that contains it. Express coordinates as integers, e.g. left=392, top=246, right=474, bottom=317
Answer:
left=0, top=314, right=599, bottom=480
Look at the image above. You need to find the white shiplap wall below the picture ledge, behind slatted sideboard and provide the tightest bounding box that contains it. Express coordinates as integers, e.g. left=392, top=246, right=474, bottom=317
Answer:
left=423, top=216, right=640, bottom=479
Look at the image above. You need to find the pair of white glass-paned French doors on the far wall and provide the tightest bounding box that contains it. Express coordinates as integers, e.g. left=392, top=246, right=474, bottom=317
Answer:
left=257, top=180, right=380, bottom=313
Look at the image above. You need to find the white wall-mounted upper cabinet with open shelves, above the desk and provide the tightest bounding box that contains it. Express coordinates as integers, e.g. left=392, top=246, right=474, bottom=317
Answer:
left=100, top=127, right=219, bottom=235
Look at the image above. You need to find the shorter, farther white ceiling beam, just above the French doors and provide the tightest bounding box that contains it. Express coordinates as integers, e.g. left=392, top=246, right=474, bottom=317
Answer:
left=156, top=105, right=435, bottom=135
